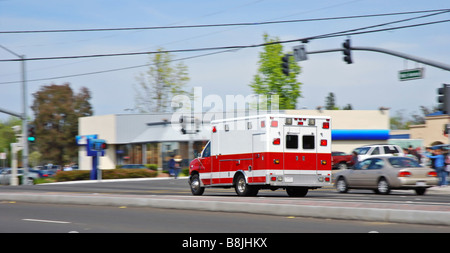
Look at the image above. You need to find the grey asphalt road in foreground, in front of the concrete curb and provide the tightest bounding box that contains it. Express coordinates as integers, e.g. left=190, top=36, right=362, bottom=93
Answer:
left=0, top=201, right=450, bottom=232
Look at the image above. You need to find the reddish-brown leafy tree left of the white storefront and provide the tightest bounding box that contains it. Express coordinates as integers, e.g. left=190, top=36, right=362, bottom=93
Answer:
left=31, top=83, right=92, bottom=165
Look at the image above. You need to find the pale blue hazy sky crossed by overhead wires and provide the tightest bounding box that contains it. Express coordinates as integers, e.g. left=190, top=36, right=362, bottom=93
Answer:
left=0, top=0, right=450, bottom=120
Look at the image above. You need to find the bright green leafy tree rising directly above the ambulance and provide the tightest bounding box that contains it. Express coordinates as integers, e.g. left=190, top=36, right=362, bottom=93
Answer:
left=250, top=34, right=301, bottom=109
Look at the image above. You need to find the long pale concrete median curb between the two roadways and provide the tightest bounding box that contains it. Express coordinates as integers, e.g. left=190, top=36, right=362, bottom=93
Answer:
left=0, top=193, right=450, bottom=226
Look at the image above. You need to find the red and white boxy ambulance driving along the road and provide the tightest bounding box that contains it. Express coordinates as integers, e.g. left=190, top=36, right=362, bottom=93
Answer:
left=189, top=114, right=331, bottom=197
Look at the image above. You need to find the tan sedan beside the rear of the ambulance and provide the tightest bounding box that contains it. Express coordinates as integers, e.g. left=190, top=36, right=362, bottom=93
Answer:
left=334, top=156, right=438, bottom=195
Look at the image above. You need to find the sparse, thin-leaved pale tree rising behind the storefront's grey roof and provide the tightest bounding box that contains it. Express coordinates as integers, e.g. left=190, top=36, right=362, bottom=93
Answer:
left=135, top=49, right=189, bottom=112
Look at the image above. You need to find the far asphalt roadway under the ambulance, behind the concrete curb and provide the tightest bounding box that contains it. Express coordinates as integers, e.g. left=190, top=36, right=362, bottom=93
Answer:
left=0, top=178, right=450, bottom=206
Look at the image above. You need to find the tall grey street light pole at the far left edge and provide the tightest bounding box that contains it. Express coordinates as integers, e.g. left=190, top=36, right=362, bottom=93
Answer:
left=0, top=45, right=28, bottom=185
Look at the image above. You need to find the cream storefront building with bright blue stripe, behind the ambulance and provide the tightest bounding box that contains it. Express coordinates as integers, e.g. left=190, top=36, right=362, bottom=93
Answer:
left=79, top=110, right=390, bottom=170
